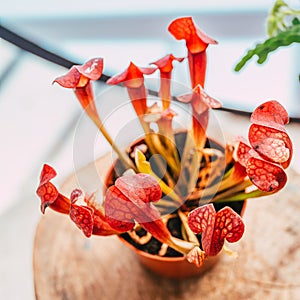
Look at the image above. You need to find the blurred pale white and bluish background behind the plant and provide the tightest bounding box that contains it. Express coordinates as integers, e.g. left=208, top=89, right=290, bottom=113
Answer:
left=0, top=0, right=300, bottom=299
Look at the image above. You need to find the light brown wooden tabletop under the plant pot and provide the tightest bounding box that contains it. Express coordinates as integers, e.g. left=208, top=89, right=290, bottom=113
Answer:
left=33, top=156, right=300, bottom=300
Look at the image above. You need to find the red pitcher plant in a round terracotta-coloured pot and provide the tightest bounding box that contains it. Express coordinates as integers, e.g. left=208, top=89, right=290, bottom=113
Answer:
left=37, top=17, right=292, bottom=277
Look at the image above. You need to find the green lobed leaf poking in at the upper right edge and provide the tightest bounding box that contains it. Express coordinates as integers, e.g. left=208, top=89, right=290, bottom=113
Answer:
left=234, top=20, right=300, bottom=72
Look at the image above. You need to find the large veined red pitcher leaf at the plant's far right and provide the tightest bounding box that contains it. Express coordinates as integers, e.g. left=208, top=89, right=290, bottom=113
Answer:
left=237, top=101, right=293, bottom=192
